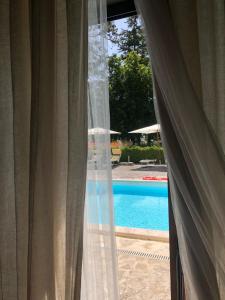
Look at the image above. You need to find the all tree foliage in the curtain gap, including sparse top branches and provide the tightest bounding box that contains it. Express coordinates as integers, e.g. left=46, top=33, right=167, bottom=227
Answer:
left=109, top=17, right=156, bottom=135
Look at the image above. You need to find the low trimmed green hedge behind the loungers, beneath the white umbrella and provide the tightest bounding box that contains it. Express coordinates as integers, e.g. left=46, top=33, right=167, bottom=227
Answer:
left=120, top=146, right=165, bottom=163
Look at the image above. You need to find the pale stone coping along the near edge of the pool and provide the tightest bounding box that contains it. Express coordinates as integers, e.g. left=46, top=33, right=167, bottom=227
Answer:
left=115, top=226, right=169, bottom=243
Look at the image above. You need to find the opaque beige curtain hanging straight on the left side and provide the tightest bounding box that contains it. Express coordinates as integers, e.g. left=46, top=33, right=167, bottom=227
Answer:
left=0, top=0, right=88, bottom=300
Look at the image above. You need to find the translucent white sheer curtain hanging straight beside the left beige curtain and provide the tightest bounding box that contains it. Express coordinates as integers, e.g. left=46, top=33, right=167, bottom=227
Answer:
left=82, top=0, right=118, bottom=300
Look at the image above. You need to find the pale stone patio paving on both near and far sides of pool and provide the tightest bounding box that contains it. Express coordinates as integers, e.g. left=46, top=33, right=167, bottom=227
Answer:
left=112, top=165, right=170, bottom=300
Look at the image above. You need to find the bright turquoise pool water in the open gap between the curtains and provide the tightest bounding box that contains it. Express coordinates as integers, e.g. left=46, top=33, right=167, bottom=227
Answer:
left=113, top=181, right=169, bottom=231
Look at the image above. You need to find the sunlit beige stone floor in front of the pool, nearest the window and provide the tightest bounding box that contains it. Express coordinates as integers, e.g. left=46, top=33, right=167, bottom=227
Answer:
left=117, top=237, right=170, bottom=300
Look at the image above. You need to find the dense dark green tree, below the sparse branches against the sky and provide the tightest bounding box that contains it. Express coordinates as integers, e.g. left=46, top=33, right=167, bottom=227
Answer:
left=109, top=51, right=156, bottom=135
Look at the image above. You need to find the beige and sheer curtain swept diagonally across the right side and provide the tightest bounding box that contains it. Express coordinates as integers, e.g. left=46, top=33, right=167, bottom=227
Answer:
left=136, top=0, right=225, bottom=300
